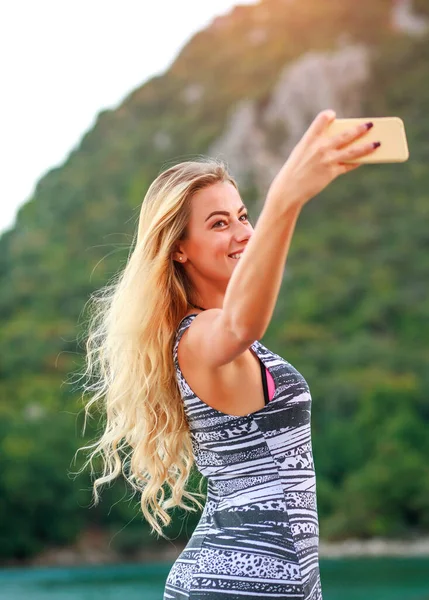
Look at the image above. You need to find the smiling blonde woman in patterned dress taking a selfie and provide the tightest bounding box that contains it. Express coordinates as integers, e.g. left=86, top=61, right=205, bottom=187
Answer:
left=79, top=110, right=375, bottom=600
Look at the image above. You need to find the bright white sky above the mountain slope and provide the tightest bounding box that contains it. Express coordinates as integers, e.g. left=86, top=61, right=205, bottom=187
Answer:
left=0, top=0, right=257, bottom=235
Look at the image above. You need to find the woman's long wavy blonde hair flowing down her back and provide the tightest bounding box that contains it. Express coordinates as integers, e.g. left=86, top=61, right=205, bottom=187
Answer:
left=78, top=157, right=237, bottom=537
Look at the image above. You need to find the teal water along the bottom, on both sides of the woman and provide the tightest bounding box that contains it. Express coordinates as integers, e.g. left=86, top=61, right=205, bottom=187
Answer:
left=0, top=557, right=429, bottom=600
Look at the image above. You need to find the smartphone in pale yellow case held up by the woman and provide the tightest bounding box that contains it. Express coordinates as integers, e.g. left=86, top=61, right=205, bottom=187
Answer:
left=326, top=117, right=410, bottom=164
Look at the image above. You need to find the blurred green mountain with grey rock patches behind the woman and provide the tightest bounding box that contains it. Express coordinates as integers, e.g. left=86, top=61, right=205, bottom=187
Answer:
left=0, top=0, right=429, bottom=561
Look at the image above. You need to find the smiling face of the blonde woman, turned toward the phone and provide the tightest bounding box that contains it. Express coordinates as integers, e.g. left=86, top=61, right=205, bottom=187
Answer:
left=176, top=182, right=253, bottom=289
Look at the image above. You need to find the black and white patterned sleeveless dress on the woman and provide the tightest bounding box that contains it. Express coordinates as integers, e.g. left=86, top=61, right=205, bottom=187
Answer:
left=163, top=314, right=322, bottom=600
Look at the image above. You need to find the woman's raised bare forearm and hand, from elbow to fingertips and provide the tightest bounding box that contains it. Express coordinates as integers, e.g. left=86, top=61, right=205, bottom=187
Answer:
left=223, top=110, right=375, bottom=341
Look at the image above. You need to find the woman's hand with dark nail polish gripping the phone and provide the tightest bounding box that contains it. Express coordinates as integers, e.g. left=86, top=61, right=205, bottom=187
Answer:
left=268, top=110, right=376, bottom=206
